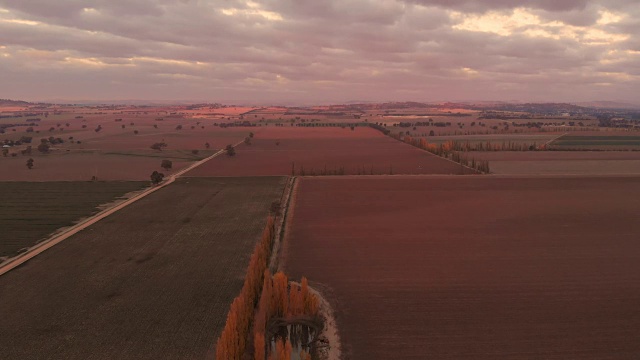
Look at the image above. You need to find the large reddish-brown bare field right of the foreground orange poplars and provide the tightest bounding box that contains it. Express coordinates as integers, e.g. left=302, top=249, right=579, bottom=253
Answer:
left=284, top=176, right=640, bottom=360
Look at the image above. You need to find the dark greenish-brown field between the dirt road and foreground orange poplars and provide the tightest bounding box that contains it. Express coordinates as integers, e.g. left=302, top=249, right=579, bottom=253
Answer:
left=0, top=177, right=286, bottom=359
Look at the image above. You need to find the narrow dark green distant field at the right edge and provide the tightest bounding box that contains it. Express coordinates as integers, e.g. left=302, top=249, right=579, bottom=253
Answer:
left=551, top=133, right=640, bottom=150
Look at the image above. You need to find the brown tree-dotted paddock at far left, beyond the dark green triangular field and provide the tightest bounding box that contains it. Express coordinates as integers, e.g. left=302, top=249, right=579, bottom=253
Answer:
left=0, top=110, right=253, bottom=181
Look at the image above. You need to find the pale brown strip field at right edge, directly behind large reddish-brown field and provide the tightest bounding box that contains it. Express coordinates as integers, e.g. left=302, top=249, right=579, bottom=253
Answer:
left=472, top=151, right=640, bottom=175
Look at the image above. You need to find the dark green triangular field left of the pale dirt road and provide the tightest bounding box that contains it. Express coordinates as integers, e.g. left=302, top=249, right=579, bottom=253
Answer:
left=0, top=181, right=148, bottom=258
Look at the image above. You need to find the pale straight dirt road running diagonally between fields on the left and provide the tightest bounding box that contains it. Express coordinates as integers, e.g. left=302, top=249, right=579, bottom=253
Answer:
left=0, top=141, right=242, bottom=276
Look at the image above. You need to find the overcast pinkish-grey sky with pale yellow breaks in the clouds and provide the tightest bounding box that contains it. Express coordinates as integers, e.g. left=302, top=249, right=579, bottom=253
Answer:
left=0, top=0, right=640, bottom=105
